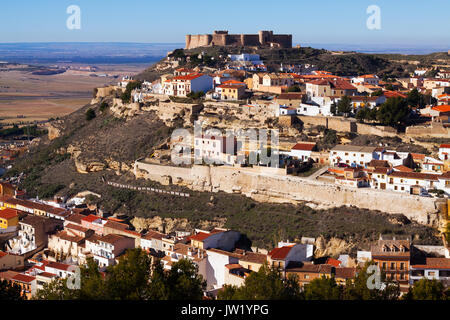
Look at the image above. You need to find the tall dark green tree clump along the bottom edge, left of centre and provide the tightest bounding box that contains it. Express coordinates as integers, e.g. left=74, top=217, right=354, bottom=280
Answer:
left=36, top=249, right=206, bottom=300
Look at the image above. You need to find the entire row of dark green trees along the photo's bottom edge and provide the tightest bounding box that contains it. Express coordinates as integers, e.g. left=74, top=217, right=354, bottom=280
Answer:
left=29, top=249, right=450, bottom=300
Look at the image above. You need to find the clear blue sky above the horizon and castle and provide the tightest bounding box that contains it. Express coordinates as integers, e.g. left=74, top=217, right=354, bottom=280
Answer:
left=0, top=0, right=450, bottom=48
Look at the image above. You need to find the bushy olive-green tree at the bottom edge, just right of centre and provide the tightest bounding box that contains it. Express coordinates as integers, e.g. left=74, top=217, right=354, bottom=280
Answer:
left=218, top=264, right=302, bottom=300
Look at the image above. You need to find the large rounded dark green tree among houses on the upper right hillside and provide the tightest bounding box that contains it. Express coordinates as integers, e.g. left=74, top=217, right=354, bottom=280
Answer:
left=377, top=97, right=411, bottom=126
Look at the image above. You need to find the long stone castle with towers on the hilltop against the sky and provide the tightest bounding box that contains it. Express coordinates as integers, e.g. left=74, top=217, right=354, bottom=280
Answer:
left=186, top=31, right=292, bottom=49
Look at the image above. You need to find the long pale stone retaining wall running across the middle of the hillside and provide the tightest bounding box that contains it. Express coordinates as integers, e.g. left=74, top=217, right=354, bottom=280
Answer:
left=135, top=162, right=440, bottom=227
